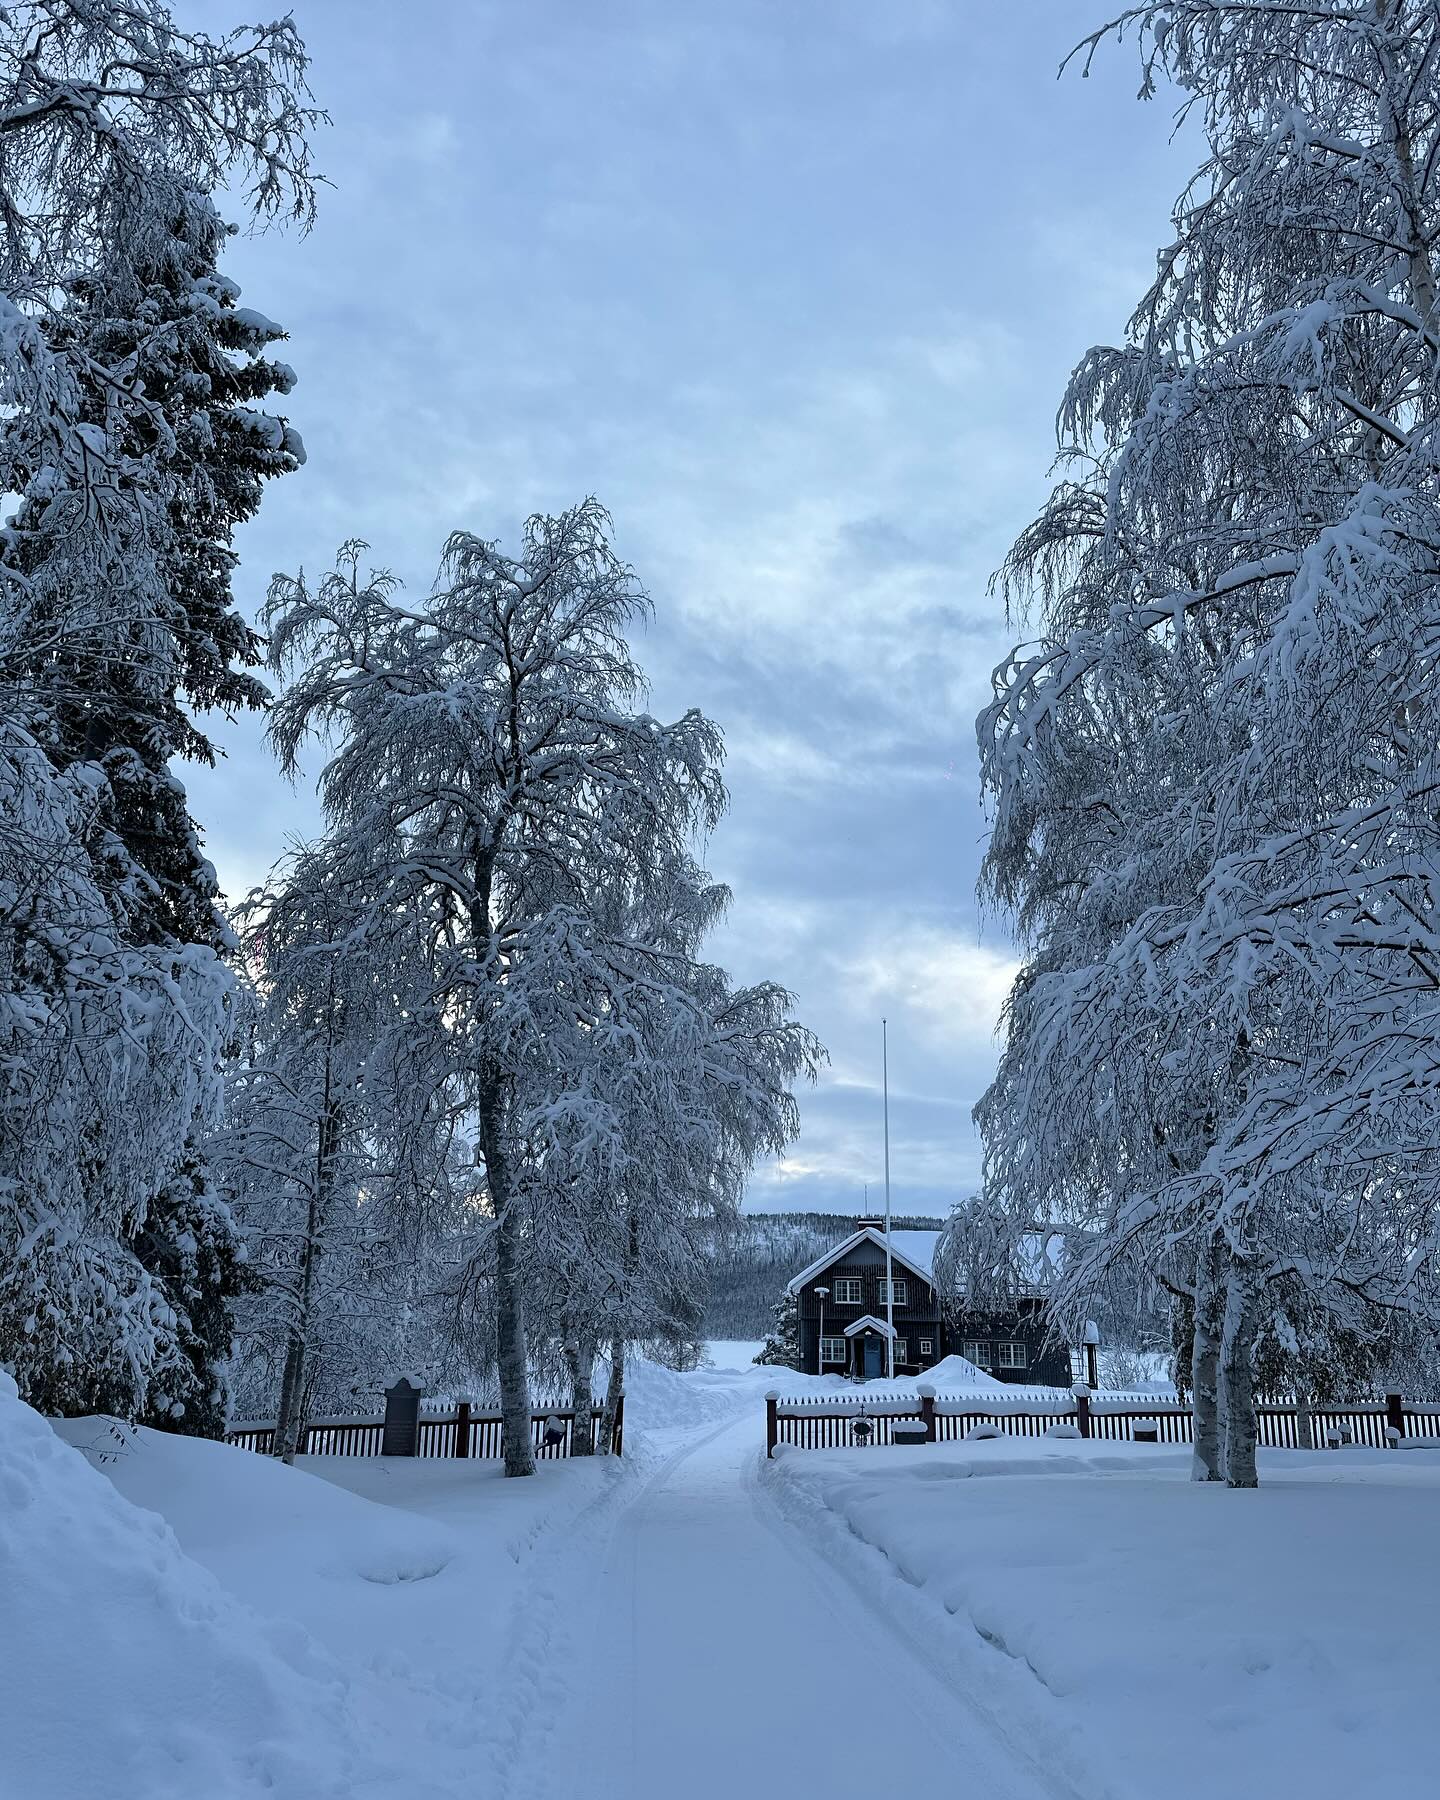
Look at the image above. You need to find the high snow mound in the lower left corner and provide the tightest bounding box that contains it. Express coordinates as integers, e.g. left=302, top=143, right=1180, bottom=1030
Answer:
left=0, top=1372, right=390, bottom=1800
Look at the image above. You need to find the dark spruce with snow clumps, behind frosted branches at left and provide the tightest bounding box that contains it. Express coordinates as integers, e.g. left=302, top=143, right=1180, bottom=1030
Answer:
left=39, top=193, right=302, bottom=1429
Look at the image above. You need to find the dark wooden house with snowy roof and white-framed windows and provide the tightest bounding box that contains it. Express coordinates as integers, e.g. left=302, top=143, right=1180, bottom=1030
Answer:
left=787, top=1219, right=1071, bottom=1388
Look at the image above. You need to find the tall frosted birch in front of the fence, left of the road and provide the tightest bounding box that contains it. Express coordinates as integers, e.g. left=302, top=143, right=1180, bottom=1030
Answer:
left=266, top=502, right=741, bottom=1474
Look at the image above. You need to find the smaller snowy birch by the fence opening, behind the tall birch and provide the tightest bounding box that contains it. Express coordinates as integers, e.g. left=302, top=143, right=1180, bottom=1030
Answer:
left=511, top=859, right=824, bottom=1445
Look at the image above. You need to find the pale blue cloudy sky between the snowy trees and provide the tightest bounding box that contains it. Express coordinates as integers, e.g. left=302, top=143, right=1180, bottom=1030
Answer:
left=190, top=0, right=1195, bottom=1211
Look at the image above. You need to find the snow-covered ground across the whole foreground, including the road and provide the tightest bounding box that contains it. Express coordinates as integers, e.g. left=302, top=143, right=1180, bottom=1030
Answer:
left=0, top=1363, right=1440, bottom=1800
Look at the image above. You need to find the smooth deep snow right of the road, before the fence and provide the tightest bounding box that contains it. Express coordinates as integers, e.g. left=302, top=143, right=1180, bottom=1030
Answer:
left=767, top=1438, right=1440, bottom=1800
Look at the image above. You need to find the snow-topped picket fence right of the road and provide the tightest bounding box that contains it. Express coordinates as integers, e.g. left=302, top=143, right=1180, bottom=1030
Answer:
left=765, top=1388, right=1440, bottom=1456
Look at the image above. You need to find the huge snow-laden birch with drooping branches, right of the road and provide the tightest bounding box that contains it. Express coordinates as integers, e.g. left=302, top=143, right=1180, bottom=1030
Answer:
left=979, top=0, right=1440, bottom=1487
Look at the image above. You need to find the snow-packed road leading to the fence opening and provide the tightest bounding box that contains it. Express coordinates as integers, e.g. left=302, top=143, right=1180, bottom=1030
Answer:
left=497, top=1415, right=1069, bottom=1800
